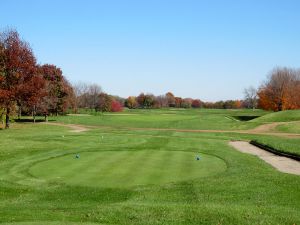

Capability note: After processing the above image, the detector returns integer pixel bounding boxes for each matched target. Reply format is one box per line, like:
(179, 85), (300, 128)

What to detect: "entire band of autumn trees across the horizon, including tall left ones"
(0, 30), (300, 128)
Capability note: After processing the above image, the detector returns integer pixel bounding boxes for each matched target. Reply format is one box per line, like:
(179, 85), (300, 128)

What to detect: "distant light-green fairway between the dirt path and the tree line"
(55, 109), (267, 130)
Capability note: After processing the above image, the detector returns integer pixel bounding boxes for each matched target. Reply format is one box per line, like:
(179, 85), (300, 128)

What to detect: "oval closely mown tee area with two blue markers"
(29, 150), (226, 188)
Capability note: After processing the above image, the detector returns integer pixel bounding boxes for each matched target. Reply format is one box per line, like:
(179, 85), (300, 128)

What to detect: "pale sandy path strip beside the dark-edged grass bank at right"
(229, 141), (300, 175)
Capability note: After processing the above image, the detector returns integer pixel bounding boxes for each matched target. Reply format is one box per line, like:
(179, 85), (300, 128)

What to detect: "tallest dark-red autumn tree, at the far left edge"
(0, 30), (42, 128)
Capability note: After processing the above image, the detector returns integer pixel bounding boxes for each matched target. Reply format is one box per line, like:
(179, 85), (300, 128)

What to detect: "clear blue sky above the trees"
(0, 0), (300, 101)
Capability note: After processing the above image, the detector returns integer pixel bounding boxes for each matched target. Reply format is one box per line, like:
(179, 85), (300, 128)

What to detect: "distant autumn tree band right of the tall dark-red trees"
(65, 67), (300, 112)
